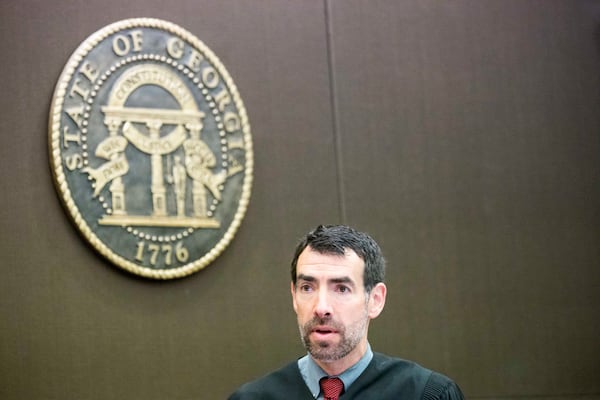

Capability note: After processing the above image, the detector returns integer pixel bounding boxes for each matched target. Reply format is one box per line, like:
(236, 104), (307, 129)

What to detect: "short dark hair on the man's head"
(291, 225), (385, 293)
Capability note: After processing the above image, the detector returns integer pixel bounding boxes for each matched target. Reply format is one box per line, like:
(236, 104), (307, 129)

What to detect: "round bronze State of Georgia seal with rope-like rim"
(49, 18), (253, 279)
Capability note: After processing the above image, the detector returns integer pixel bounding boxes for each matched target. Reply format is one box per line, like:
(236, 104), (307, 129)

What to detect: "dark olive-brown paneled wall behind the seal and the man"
(0, 0), (600, 400)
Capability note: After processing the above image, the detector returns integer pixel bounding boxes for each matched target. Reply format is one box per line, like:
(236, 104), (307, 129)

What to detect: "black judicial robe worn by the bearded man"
(229, 353), (464, 400)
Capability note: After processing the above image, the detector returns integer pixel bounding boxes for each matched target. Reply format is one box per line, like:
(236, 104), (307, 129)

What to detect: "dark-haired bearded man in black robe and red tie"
(230, 225), (463, 400)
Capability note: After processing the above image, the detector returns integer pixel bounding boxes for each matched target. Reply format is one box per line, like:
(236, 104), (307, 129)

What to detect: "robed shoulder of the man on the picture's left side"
(229, 361), (305, 400)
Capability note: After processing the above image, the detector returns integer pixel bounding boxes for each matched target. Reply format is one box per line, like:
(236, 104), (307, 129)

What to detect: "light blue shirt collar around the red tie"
(298, 343), (373, 399)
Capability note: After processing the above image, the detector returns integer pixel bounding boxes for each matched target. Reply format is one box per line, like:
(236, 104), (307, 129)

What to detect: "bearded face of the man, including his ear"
(292, 247), (385, 365)
